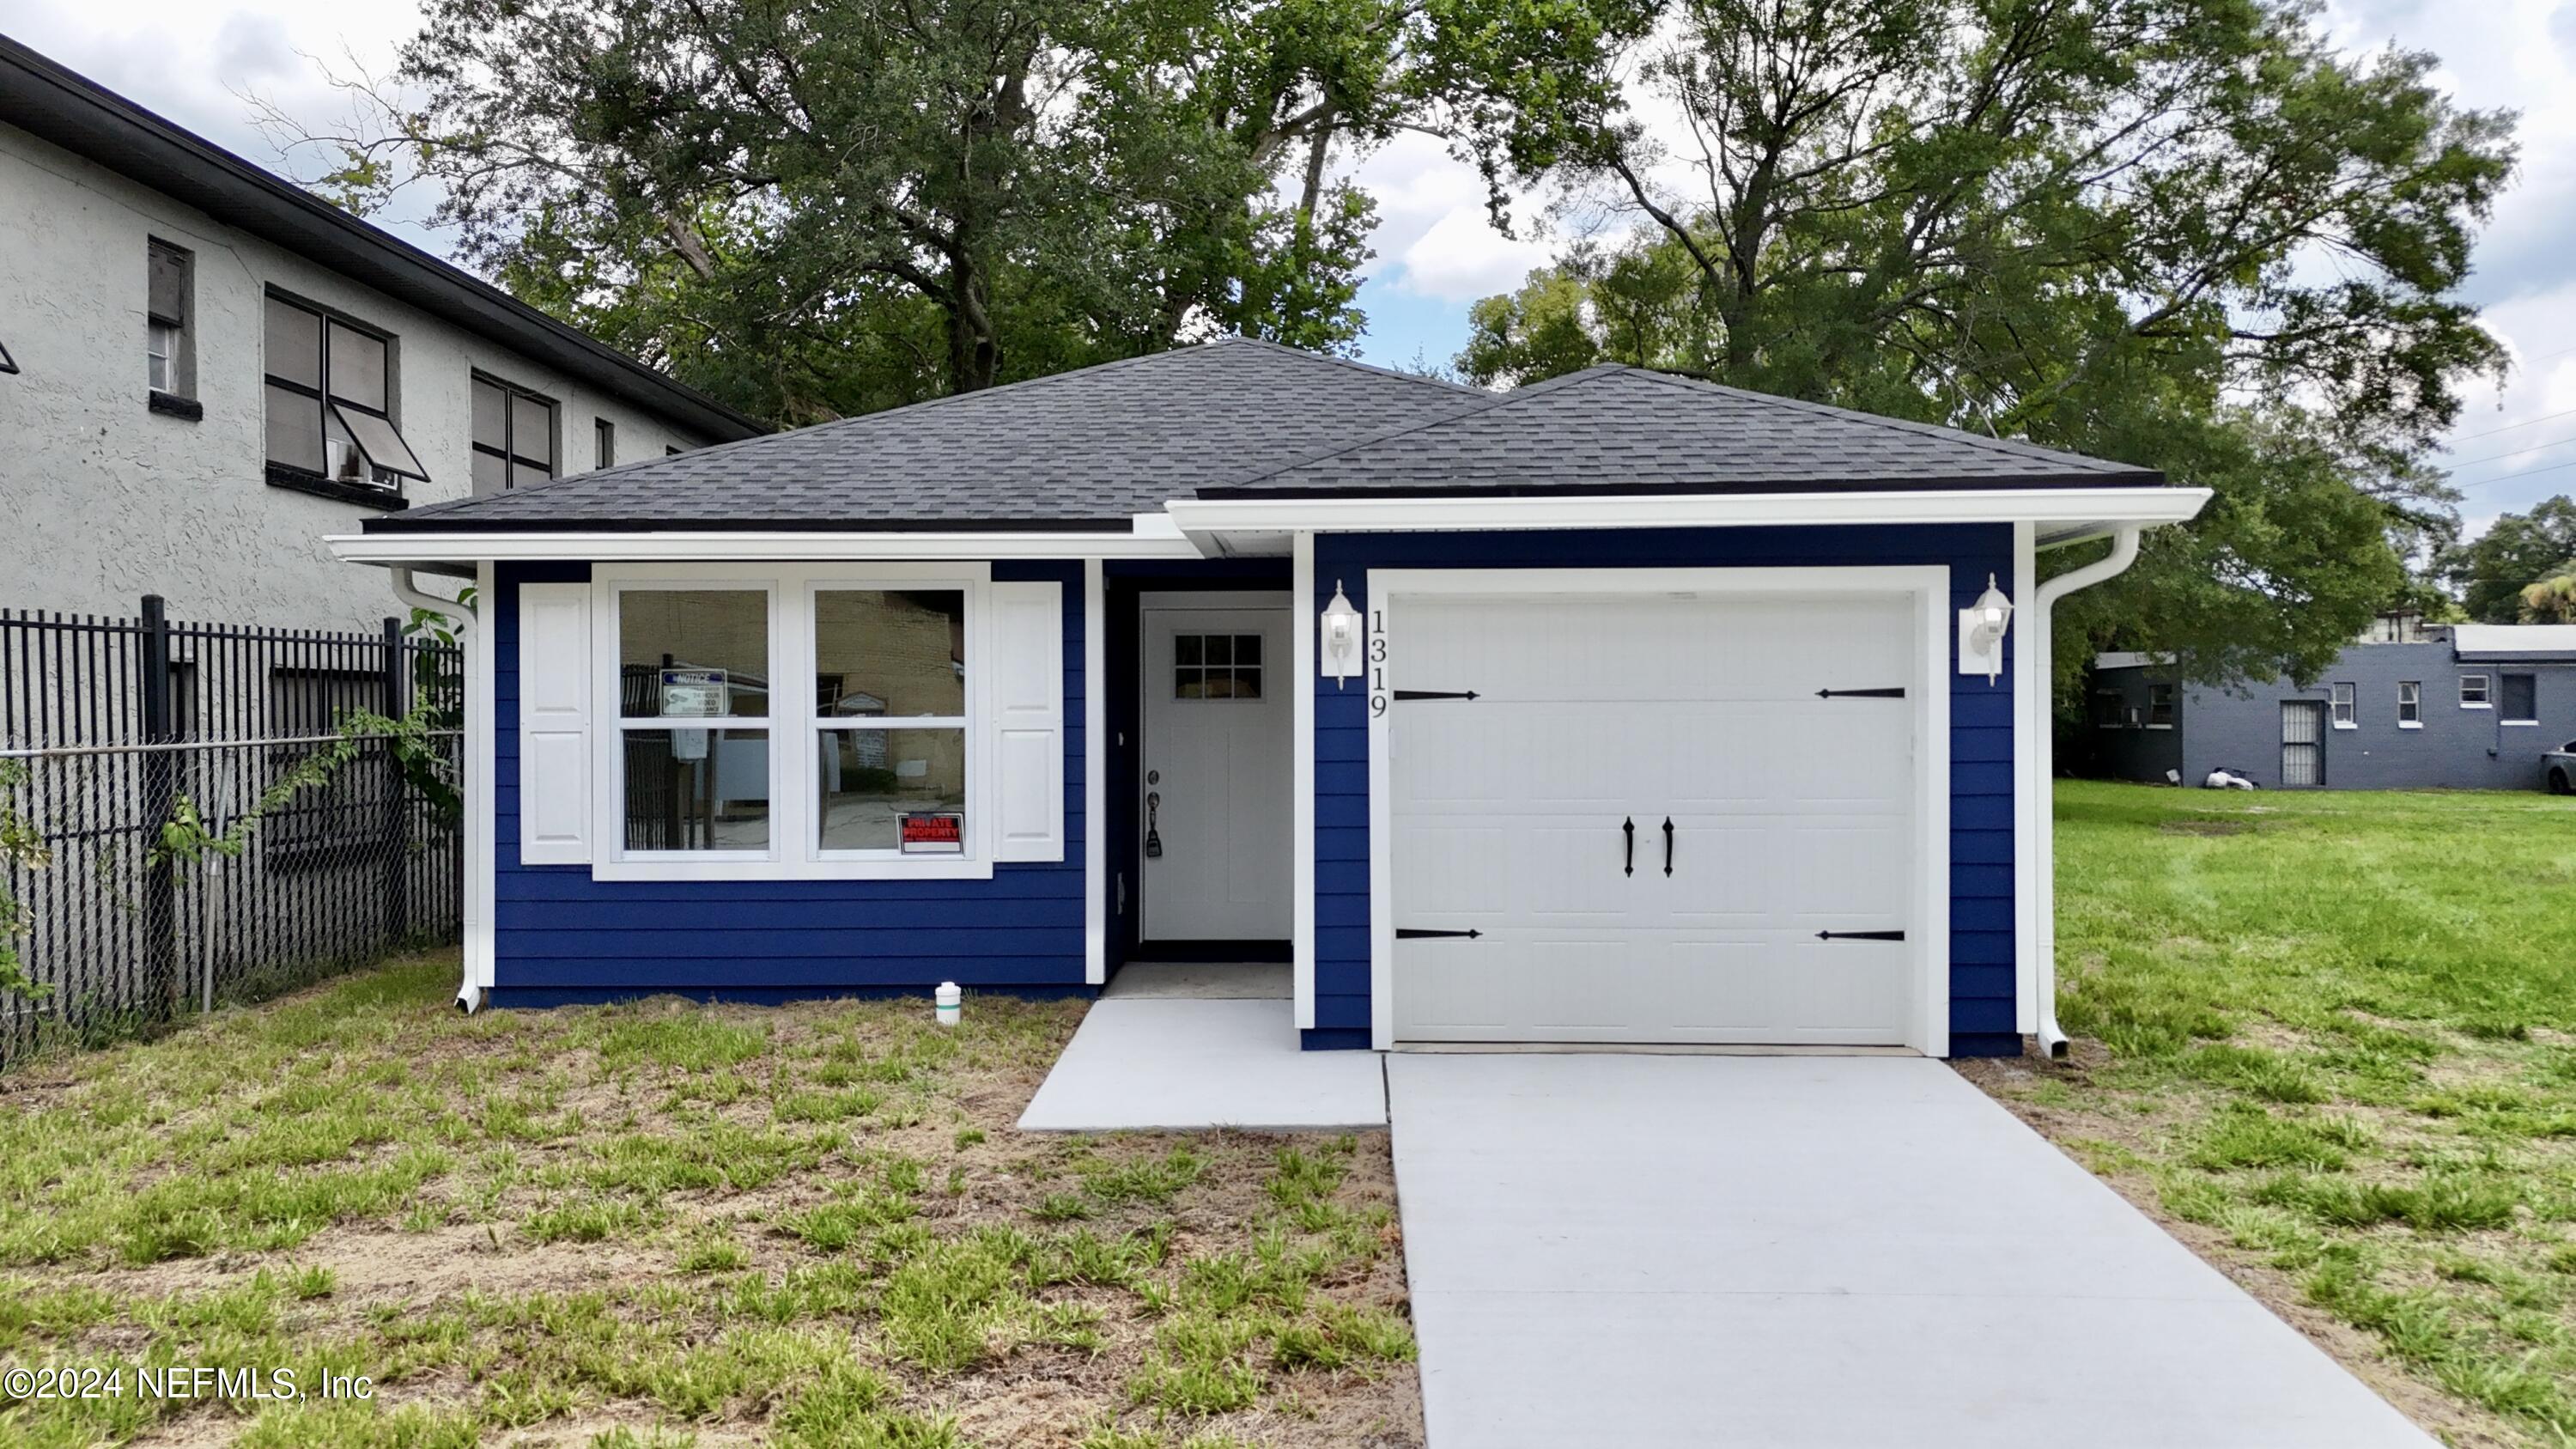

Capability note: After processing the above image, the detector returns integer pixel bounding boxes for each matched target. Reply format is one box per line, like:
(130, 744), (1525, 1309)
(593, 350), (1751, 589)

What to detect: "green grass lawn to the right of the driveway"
(1968, 784), (2576, 1444)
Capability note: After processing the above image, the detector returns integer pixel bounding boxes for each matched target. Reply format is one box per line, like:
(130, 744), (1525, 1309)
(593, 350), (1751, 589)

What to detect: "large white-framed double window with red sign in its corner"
(592, 562), (999, 880)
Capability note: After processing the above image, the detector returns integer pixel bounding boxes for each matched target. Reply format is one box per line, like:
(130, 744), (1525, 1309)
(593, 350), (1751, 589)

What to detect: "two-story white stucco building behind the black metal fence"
(0, 36), (762, 629)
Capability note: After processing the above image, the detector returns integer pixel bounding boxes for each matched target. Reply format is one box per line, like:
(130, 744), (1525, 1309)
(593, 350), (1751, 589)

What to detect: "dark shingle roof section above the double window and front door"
(368, 338), (1492, 533)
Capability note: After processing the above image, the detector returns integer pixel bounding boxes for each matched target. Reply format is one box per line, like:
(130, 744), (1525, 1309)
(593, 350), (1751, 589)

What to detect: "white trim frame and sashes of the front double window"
(590, 562), (994, 882)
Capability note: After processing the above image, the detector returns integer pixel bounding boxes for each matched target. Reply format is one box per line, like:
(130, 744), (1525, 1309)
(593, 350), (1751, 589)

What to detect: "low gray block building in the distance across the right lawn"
(2061, 618), (2576, 789)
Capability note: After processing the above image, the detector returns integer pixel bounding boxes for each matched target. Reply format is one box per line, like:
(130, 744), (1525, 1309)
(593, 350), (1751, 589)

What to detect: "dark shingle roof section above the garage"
(1200, 366), (2164, 497)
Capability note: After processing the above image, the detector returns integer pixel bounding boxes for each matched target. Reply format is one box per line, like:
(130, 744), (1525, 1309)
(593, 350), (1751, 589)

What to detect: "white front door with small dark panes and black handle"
(1139, 595), (1298, 941)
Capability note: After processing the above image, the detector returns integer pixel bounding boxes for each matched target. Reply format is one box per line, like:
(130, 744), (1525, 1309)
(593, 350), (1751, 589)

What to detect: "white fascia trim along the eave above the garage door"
(1164, 487), (2210, 551)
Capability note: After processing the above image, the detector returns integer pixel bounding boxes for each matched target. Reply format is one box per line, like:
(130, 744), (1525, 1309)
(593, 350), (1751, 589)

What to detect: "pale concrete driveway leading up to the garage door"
(1386, 1055), (2432, 1449)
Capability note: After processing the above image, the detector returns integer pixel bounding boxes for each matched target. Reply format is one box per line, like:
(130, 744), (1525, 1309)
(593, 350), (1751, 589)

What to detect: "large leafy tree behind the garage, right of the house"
(1461, 0), (2514, 680)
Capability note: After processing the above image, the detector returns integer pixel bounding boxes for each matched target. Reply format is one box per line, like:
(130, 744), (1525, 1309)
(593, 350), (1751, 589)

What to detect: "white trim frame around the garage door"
(1363, 564), (1955, 1057)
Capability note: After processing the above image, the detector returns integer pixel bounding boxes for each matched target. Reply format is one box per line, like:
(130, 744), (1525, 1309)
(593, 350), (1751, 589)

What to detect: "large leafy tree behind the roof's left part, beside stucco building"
(283, 0), (1636, 423)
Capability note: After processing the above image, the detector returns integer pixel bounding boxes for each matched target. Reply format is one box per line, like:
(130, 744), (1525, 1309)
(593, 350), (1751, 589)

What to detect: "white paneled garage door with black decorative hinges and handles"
(1388, 593), (1919, 1044)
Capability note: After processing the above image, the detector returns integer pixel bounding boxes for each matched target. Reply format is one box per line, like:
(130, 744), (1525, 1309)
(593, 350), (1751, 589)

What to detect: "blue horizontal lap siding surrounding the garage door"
(1306, 523), (2022, 1057)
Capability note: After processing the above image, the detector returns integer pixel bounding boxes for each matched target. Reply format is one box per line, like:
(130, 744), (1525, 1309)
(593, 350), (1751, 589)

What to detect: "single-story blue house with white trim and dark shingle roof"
(332, 338), (2208, 1055)
